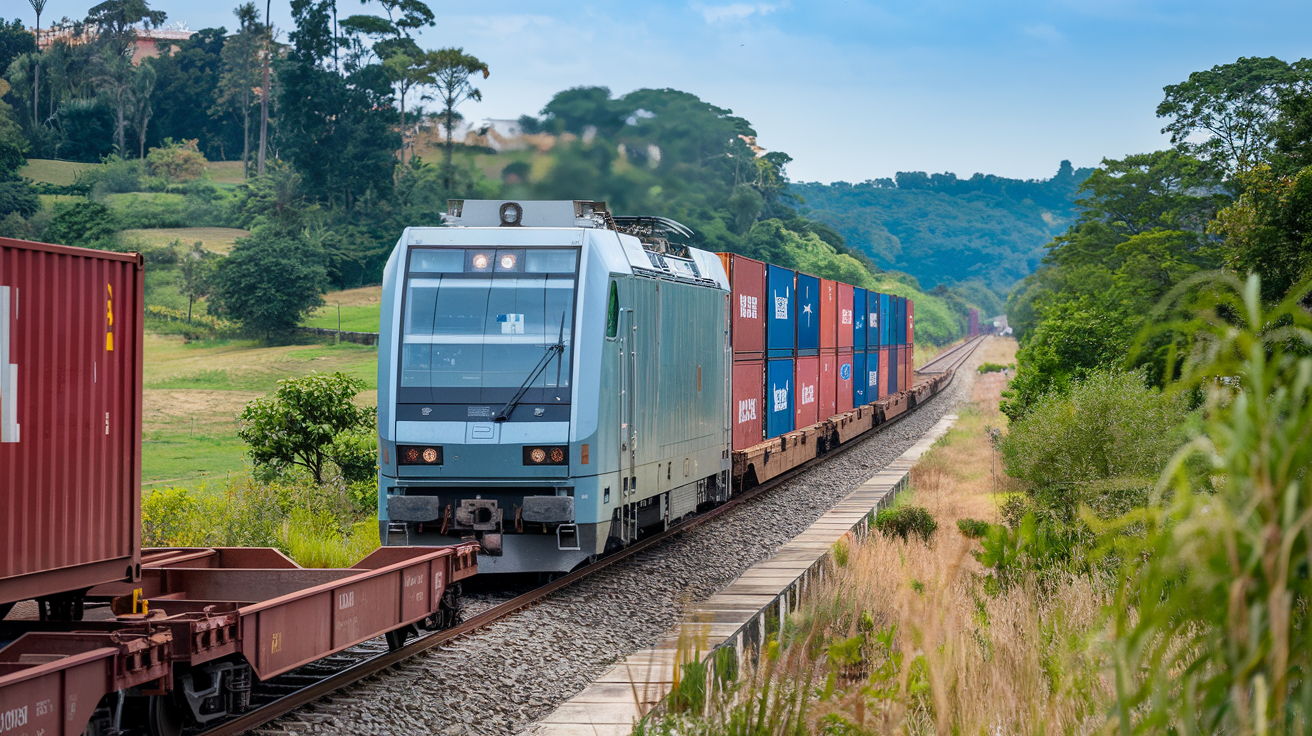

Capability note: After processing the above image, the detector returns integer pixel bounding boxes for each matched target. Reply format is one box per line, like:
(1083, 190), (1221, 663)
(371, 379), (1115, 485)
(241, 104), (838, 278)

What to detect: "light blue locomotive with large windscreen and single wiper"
(378, 201), (731, 573)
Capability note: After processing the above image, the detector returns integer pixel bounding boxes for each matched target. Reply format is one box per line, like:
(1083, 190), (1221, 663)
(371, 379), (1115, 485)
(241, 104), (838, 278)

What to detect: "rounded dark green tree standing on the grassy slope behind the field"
(213, 227), (328, 338)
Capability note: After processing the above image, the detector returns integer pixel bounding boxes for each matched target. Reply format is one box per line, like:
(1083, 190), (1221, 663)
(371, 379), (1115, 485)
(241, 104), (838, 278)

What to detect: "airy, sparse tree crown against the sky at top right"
(1157, 56), (1303, 176)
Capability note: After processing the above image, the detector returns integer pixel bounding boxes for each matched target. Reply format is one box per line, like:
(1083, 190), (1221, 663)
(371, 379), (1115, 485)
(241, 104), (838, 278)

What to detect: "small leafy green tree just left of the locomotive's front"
(237, 373), (377, 483)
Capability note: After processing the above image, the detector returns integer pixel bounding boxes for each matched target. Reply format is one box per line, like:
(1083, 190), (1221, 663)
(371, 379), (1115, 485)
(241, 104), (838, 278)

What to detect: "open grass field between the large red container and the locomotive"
(142, 335), (378, 489)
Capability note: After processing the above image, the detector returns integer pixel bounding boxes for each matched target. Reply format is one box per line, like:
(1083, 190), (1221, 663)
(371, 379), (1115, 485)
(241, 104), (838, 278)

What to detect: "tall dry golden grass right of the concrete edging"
(639, 338), (1114, 735)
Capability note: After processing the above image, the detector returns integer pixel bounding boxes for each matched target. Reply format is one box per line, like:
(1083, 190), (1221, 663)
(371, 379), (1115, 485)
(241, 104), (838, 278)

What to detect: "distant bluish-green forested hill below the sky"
(790, 161), (1093, 291)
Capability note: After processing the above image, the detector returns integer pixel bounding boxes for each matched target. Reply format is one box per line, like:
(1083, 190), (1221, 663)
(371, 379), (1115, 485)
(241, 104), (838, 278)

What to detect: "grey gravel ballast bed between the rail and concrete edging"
(260, 353), (979, 736)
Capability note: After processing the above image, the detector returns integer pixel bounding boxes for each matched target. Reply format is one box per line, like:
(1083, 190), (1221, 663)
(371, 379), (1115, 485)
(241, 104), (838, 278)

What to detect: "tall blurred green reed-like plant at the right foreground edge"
(1109, 276), (1312, 735)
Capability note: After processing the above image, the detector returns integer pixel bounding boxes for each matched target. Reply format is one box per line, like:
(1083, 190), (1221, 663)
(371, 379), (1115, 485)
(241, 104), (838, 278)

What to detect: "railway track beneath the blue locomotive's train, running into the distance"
(195, 336), (985, 736)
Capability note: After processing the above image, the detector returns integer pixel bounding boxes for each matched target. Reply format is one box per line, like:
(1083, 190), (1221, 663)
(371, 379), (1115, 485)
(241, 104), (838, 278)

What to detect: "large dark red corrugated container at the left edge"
(0, 237), (144, 606)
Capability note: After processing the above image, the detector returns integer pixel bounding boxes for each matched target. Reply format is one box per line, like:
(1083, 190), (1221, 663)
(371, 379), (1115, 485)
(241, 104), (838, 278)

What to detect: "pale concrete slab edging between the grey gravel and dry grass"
(525, 415), (956, 736)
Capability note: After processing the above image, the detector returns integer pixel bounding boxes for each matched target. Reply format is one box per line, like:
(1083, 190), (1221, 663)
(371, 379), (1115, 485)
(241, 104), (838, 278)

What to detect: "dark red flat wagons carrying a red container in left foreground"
(0, 239), (478, 736)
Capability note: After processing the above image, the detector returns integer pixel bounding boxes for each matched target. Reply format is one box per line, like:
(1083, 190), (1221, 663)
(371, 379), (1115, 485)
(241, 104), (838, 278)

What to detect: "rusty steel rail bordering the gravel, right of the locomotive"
(197, 335), (987, 736)
